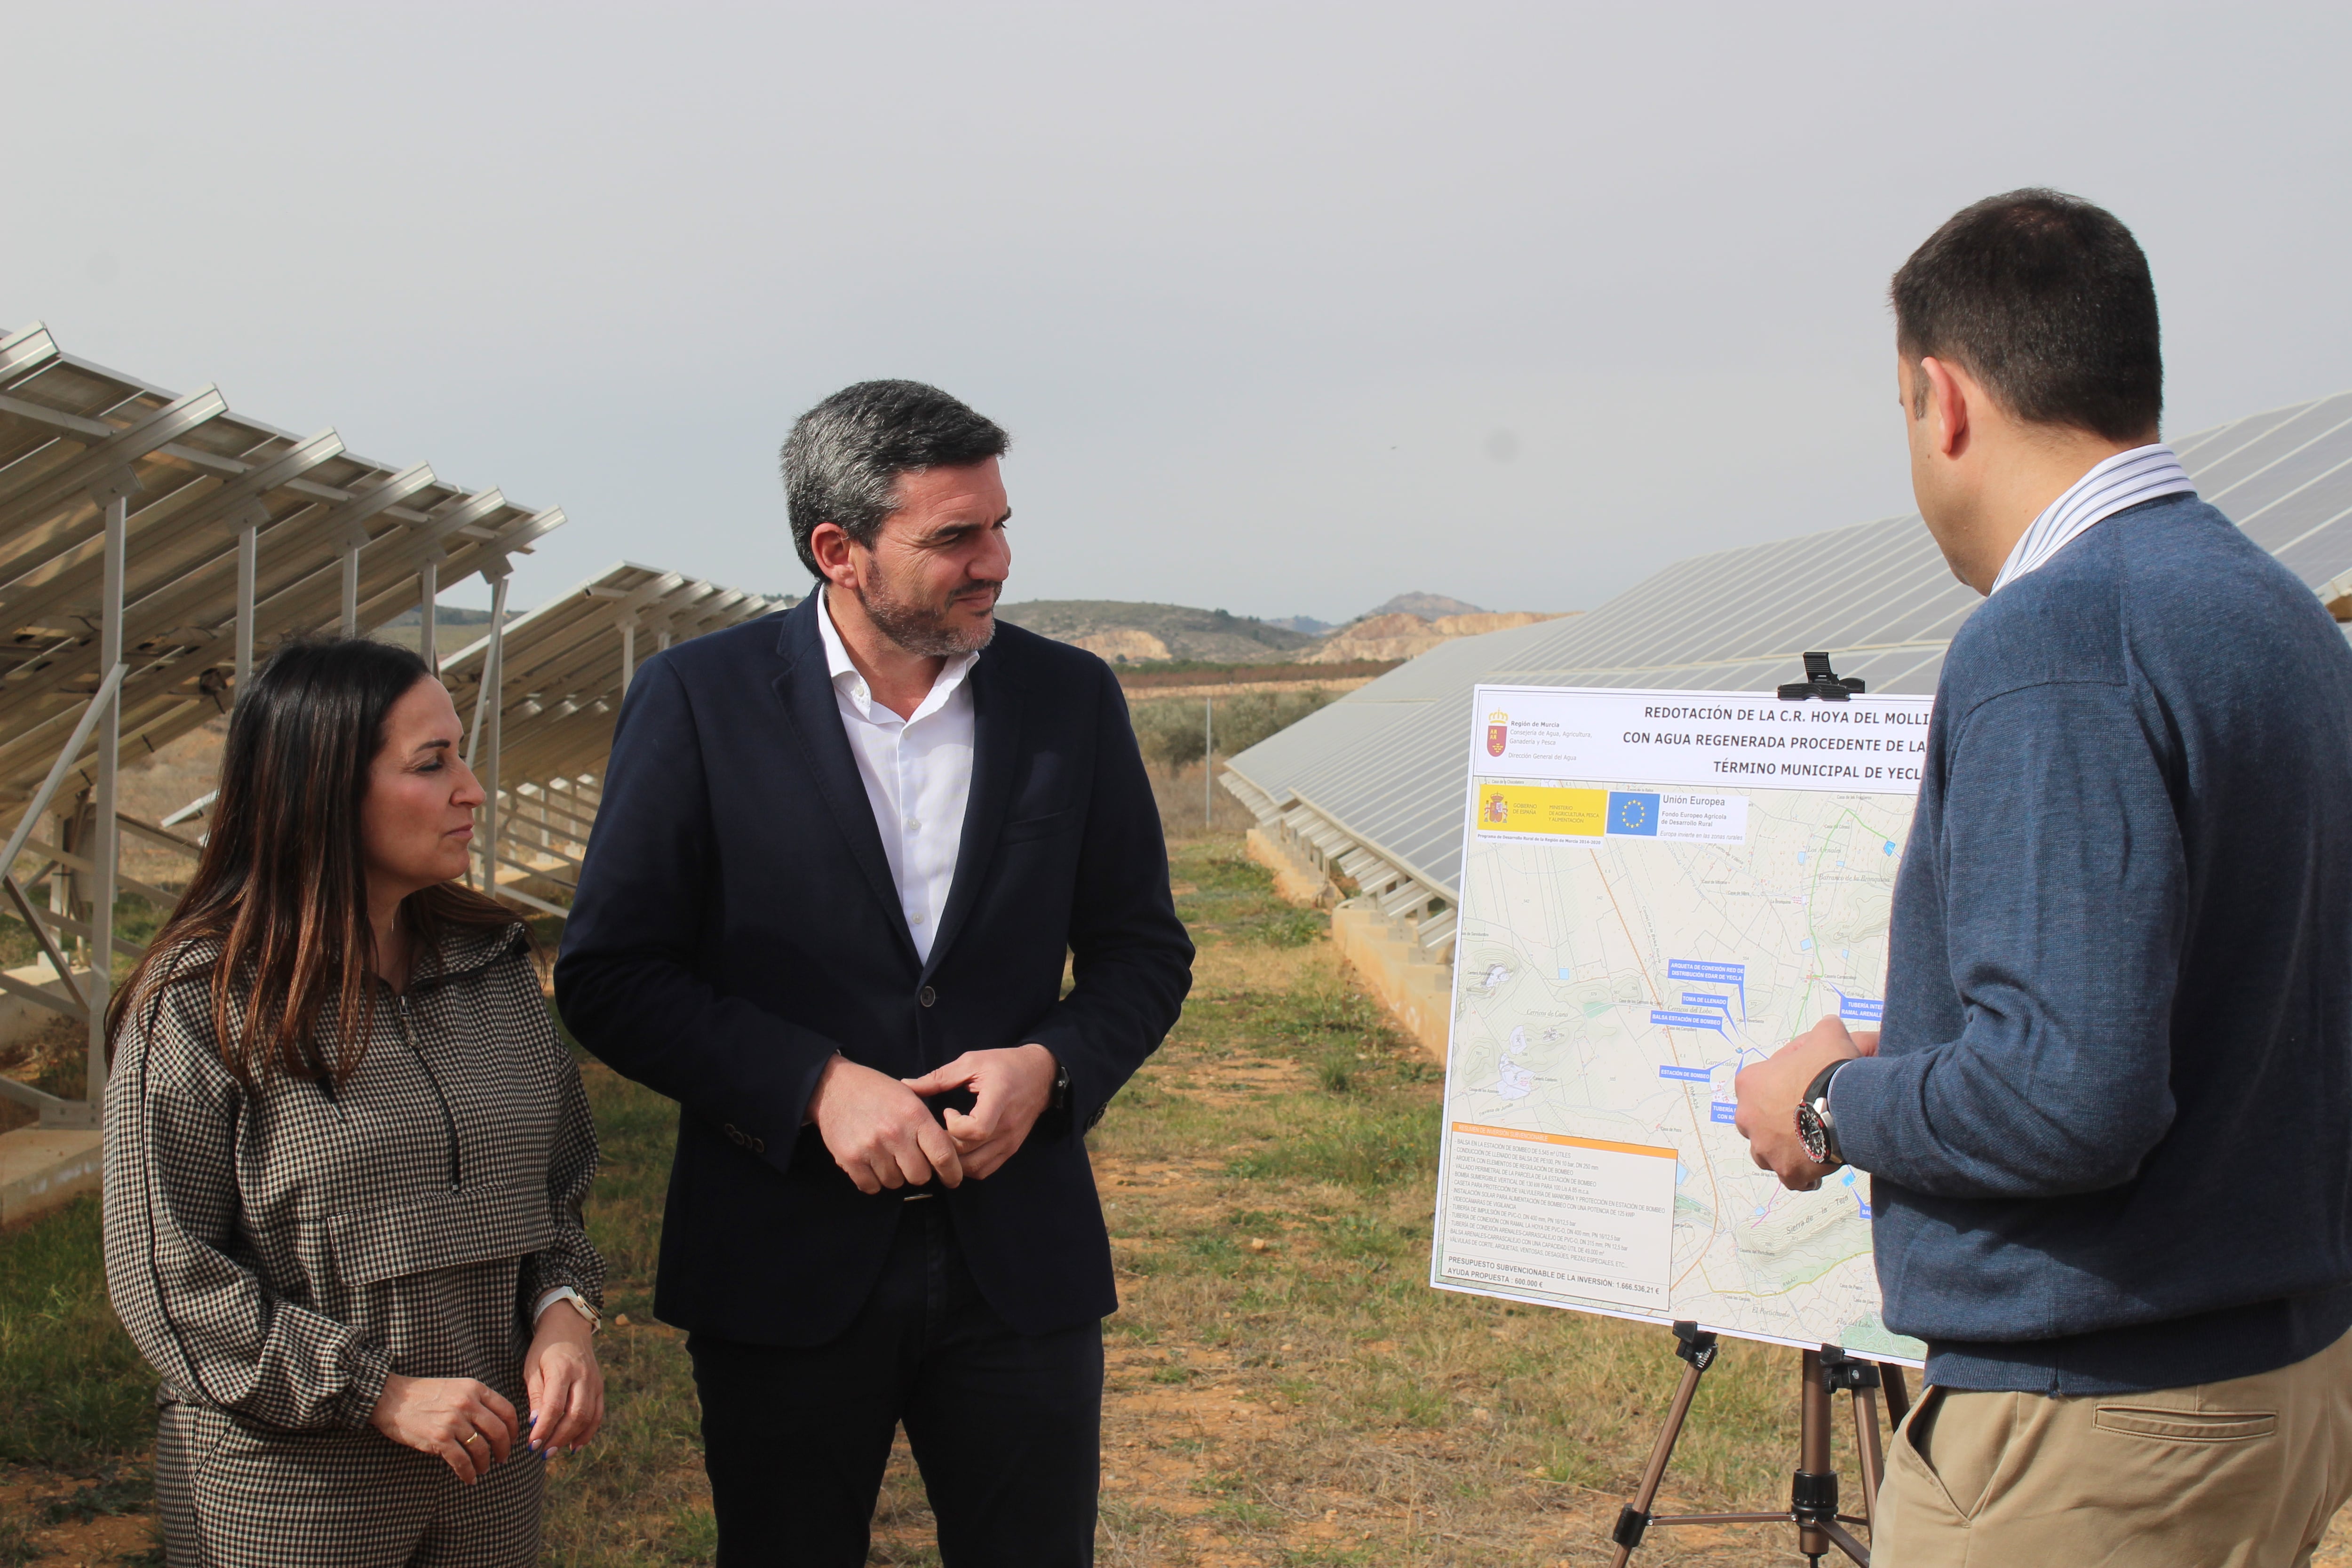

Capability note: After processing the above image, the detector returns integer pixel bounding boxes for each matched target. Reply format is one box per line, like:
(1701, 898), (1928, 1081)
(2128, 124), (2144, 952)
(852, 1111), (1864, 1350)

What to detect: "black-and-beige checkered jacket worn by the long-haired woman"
(106, 926), (604, 1432)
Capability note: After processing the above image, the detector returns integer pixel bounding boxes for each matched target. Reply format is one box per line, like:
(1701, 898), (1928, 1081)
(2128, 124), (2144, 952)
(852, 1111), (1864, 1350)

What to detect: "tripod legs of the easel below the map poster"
(1611, 1323), (1910, 1568)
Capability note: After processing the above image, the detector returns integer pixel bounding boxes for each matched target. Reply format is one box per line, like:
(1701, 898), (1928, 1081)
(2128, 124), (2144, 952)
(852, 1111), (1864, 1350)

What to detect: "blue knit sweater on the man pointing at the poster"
(1830, 496), (2352, 1394)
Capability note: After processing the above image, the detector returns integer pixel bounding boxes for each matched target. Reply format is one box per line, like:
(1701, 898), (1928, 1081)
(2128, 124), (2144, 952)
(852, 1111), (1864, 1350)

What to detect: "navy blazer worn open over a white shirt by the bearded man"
(555, 595), (1192, 1345)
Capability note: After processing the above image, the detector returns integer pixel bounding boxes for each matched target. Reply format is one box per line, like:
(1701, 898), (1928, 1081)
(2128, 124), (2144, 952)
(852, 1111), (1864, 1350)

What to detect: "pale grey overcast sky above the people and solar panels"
(0, 0), (2352, 618)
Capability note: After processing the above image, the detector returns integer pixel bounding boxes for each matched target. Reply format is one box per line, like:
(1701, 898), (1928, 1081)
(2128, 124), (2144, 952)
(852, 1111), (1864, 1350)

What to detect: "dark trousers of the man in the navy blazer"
(687, 1199), (1103, 1568)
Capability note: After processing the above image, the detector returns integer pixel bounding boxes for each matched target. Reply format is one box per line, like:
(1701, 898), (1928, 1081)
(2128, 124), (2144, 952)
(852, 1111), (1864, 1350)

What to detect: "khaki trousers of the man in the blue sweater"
(1870, 1335), (2352, 1568)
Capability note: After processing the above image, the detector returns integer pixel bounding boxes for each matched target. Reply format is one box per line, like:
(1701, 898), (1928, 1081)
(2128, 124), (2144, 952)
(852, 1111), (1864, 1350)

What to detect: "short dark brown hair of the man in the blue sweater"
(1889, 191), (2164, 442)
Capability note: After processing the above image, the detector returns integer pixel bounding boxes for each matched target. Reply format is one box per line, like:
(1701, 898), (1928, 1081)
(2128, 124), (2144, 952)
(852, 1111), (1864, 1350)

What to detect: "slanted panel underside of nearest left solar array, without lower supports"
(0, 327), (564, 799)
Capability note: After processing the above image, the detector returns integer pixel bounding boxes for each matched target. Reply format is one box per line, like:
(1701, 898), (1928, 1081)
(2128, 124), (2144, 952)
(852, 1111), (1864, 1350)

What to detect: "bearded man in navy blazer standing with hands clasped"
(555, 381), (1192, 1568)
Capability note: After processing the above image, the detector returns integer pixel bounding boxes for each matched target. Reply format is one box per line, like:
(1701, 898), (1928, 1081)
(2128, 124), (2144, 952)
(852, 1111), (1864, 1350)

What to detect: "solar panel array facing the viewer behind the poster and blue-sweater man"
(1223, 392), (2352, 950)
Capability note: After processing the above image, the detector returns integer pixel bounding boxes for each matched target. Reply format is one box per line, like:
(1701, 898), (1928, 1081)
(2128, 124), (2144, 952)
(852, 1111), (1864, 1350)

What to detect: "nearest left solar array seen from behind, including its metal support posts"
(0, 327), (562, 1126)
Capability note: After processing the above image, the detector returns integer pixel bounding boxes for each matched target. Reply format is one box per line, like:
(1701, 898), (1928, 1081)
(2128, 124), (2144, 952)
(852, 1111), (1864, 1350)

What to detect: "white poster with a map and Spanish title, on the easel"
(1430, 686), (1931, 1361)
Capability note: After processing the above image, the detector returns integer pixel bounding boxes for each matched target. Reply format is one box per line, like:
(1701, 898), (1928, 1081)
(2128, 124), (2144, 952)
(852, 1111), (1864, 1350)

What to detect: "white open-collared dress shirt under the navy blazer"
(816, 588), (981, 962)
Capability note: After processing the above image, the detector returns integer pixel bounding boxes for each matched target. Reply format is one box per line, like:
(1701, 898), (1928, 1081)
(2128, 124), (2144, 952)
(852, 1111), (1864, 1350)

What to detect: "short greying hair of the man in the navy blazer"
(783, 381), (1014, 576)
